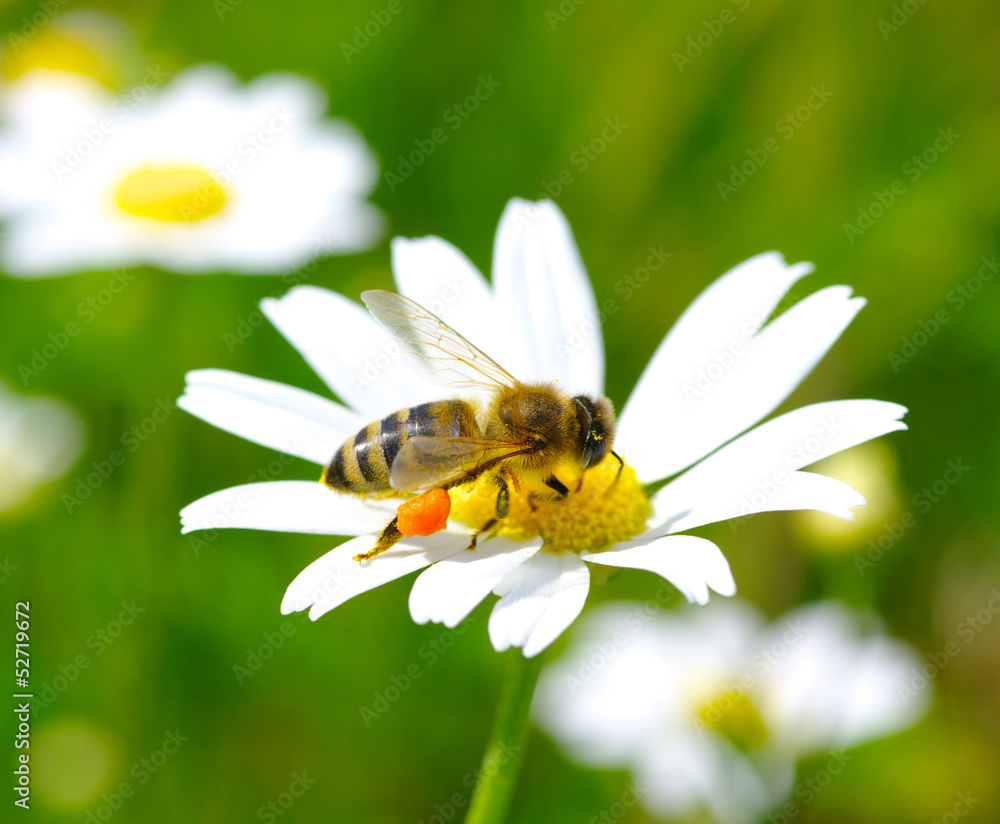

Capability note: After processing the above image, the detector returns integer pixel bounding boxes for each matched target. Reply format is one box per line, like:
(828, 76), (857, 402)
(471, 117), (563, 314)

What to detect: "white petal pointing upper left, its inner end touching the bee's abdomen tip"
(177, 369), (368, 466)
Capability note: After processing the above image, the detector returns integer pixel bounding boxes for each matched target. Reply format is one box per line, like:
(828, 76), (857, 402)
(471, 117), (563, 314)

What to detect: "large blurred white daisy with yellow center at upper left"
(0, 65), (381, 277)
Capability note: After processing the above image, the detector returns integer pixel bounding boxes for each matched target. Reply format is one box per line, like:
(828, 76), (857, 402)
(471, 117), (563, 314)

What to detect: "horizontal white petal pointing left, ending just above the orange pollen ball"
(181, 481), (395, 535)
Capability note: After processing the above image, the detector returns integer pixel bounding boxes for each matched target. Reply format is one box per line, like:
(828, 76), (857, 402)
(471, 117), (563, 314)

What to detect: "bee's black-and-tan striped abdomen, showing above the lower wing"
(321, 401), (479, 497)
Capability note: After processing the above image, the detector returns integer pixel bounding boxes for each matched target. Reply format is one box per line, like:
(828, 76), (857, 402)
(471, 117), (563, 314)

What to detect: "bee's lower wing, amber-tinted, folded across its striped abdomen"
(389, 435), (530, 492)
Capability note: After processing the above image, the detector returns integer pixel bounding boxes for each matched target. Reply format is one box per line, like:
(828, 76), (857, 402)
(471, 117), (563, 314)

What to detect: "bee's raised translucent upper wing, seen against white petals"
(361, 289), (517, 390)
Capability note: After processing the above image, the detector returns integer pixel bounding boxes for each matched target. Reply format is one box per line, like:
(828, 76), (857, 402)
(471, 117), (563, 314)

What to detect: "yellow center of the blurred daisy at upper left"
(116, 166), (226, 223)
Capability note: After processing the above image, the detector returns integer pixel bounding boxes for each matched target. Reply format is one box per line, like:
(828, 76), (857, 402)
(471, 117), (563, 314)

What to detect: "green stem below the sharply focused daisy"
(465, 649), (544, 824)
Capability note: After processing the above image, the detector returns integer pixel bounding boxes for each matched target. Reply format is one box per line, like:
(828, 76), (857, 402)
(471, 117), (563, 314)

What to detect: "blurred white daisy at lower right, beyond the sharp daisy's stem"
(532, 600), (929, 824)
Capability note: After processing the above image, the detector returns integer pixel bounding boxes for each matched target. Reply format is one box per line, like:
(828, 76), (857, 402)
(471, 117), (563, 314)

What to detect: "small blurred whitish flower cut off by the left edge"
(0, 383), (84, 512)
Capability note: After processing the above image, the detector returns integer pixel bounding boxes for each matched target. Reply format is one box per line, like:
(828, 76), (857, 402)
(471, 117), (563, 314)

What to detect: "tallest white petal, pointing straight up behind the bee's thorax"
(487, 198), (604, 393)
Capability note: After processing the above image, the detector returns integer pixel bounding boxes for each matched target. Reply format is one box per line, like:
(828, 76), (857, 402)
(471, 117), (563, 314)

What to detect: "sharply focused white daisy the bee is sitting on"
(178, 200), (905, 657)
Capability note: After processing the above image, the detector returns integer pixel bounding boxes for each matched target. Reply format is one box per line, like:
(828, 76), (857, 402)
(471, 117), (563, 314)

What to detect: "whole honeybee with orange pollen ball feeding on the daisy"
(321, 290), (622, 562)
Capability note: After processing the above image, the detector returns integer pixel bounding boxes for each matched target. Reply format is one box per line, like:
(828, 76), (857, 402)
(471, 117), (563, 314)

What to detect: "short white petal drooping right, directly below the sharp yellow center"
(580, 535), (736, 606)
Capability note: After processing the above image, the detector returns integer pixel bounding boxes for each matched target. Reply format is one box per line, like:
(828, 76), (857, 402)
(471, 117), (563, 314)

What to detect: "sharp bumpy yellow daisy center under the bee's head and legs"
(449, 455), (650, 552)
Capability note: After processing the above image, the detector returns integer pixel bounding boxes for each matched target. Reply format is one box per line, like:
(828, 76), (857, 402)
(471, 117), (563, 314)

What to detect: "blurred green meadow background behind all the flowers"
(0, 0), (1000, 824)
